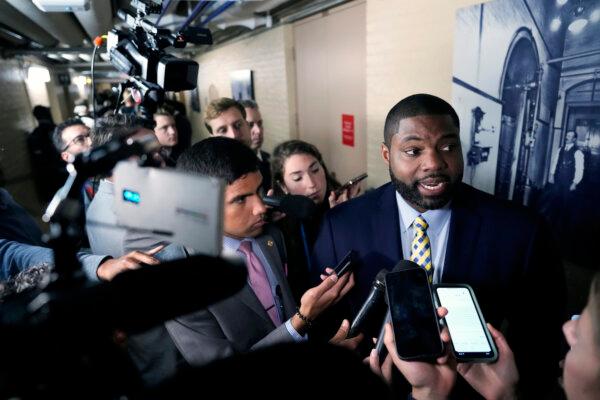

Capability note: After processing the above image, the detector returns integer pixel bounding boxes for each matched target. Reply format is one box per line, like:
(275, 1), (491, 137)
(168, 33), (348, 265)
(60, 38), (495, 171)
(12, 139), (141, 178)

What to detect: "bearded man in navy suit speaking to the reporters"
(313, 94), (566, 393)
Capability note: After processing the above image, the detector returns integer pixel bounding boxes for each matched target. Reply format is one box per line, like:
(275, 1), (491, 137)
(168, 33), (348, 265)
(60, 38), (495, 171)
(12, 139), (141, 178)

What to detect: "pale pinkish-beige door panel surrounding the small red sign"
(294, 1), (367, 182)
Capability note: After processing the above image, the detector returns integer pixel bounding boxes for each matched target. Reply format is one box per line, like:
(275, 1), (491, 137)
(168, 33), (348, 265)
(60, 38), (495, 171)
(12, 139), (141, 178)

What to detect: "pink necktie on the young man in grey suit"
(238, 240), (281, 326)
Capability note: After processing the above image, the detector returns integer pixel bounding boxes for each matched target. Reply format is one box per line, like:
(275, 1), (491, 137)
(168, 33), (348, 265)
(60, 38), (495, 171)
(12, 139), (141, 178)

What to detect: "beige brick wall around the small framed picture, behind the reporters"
(190, 25), (297, 151)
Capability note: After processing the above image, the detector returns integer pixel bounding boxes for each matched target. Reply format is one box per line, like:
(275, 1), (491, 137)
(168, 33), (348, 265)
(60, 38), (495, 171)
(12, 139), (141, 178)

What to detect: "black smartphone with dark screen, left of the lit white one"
(385, 268), (444, 361)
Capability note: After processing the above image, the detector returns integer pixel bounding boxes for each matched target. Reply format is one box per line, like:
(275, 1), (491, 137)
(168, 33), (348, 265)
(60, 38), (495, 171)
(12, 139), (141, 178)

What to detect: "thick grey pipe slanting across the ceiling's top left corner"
(6, 0), (86, 46)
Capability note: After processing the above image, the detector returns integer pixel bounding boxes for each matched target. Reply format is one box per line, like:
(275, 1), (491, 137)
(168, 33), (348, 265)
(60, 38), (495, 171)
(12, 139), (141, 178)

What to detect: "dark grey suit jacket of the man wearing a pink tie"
(163, 229), (296, 366)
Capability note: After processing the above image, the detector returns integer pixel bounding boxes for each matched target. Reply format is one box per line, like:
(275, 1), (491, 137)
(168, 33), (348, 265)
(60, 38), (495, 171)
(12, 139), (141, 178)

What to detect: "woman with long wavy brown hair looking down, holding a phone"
(271, 140), (360, 300)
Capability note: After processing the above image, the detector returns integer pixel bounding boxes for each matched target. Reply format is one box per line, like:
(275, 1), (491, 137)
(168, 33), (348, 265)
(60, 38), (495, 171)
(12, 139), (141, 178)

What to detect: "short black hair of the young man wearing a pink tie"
(177, 136), (259, 185)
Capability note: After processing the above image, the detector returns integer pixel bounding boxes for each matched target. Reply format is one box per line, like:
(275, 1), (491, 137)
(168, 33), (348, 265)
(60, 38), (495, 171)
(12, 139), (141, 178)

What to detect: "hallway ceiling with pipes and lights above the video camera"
(0, 0), (349, 72)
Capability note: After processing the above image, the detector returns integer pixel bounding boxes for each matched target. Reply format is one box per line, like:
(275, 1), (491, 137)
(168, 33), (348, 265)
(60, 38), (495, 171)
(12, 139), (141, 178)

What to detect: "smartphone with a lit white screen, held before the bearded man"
(434, 283), (498, 362)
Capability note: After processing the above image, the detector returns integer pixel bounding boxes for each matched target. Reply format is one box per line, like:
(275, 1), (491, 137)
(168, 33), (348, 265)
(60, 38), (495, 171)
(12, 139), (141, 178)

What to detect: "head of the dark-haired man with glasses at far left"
(52, 118), (92, 162)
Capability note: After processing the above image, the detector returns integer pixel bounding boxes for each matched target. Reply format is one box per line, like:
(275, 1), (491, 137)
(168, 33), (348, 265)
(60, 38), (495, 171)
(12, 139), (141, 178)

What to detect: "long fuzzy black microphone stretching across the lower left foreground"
(0, 255), (247, 334)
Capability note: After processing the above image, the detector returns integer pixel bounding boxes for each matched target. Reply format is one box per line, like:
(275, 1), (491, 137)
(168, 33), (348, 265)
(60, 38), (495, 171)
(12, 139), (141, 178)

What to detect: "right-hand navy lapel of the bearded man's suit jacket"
(441, 184), (481, 283)
